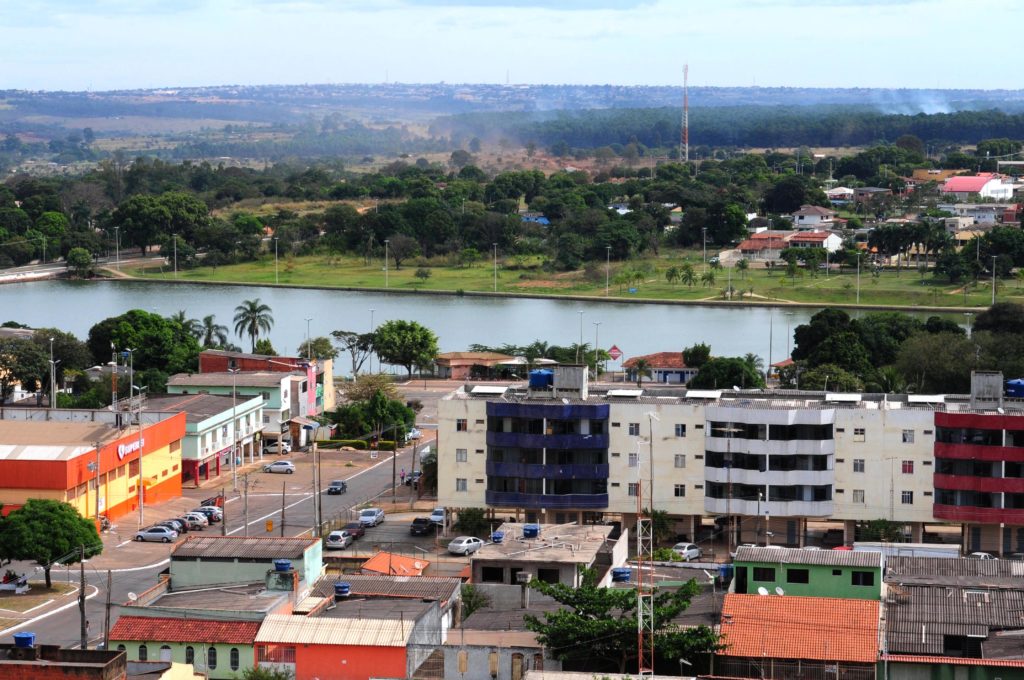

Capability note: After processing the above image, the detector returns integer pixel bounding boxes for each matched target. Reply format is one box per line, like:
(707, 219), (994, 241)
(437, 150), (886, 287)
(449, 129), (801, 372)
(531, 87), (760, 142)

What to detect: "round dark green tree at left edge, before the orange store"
(0, 499), (103, 588)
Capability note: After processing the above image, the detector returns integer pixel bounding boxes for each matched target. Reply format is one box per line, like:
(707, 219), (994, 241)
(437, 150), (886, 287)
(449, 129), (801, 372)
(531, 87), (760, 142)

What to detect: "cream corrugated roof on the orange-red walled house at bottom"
(256, 614), (414, 647)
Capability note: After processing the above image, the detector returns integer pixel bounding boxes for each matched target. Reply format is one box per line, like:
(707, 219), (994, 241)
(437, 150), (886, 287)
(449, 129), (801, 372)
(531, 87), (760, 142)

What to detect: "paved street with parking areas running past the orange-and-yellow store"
(0, 436), (434, 646)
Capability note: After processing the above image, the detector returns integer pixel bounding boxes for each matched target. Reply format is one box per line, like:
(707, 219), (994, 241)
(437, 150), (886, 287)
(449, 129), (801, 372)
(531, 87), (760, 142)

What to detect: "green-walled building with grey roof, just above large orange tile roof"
(733, 546), (883, 600)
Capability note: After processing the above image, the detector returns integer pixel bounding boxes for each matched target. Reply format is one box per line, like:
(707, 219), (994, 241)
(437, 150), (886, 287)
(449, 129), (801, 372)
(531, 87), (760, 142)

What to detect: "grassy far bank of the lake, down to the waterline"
(112, 256), (1007, 313)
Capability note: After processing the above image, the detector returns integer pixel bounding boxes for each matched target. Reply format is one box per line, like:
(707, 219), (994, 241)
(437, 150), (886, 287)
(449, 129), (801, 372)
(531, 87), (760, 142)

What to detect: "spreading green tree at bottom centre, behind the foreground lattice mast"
(523, 568), (718, 673)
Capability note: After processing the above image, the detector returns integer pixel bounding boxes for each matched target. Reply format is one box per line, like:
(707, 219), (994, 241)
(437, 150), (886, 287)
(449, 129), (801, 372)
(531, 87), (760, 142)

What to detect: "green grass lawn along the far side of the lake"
(126, 251), (1024, 307)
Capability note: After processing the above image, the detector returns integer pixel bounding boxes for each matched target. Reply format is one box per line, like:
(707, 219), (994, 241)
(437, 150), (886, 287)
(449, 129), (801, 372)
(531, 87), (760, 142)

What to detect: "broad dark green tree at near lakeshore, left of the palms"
(87, 309), (200, 374)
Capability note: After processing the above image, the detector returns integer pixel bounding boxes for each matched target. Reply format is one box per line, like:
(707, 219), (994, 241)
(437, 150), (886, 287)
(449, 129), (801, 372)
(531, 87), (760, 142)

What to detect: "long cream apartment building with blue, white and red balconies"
(438, 367), (1024, 551)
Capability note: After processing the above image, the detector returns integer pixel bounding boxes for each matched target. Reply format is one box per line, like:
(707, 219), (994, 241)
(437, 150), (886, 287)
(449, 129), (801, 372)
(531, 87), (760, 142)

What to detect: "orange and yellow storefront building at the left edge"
(0, 412), (185, 520)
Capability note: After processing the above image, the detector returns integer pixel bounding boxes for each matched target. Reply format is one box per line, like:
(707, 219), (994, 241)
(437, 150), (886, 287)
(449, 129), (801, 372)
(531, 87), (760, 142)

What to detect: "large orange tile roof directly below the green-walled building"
(722, 594), (879, 664)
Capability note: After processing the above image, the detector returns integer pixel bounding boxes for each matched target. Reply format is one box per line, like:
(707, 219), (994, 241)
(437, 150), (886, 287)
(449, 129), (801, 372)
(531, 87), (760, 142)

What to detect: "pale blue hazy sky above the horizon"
(0, 0), (1024, 90)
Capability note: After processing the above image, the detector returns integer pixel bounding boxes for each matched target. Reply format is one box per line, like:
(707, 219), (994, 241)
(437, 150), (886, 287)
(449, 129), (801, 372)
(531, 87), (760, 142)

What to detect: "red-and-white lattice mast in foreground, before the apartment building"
(637, 413), (657, 678)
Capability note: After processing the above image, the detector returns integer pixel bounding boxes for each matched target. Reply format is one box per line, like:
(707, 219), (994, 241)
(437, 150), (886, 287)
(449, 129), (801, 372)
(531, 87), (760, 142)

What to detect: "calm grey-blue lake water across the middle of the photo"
(0, 281), (962, 372)
